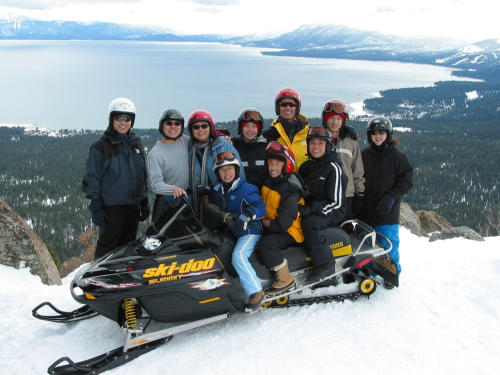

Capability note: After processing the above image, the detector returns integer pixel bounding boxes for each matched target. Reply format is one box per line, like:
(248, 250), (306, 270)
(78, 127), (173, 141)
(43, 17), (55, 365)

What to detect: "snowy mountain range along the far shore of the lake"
(0, 19), (500, 82)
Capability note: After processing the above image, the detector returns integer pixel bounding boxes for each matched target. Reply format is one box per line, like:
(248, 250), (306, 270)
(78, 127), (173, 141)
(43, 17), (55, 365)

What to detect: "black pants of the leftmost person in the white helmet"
(94, 205), (140, 259)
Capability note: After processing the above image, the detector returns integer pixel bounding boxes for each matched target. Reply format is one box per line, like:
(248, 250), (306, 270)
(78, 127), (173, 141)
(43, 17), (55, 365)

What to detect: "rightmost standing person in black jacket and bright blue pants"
(359, 116), (413, 289)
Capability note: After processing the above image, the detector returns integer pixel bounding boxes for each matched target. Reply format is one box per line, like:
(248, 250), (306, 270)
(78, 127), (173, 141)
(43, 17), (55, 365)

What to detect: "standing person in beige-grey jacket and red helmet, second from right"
(321, 99), (365, 219)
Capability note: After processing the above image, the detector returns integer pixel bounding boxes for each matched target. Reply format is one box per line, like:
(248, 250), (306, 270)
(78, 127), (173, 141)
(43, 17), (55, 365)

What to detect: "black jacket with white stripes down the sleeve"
(299, 151), (347, 223)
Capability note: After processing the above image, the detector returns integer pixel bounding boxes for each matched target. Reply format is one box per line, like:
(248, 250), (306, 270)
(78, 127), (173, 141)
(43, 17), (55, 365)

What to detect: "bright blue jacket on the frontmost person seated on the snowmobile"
(214, 177), (266, 238)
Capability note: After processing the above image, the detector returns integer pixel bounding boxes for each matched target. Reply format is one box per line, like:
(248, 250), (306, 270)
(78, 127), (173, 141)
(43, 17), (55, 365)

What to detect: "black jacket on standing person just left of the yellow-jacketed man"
(232, 136), (267, 189)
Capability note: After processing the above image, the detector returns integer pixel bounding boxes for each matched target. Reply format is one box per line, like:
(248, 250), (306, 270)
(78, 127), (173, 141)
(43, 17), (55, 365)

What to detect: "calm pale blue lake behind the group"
(0, 41), (468, 129)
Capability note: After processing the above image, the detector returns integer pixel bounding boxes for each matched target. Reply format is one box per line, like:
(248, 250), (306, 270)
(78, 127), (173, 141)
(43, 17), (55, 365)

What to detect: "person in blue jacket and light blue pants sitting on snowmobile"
(213, 151), (266, 310)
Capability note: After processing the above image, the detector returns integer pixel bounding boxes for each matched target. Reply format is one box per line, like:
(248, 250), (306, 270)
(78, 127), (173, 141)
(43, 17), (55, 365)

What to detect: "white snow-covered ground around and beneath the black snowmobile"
(0, 227), (500, 375)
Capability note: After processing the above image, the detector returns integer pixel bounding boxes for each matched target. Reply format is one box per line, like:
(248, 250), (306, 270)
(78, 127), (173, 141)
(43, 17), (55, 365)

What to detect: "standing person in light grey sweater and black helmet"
(146, 108), (189, 222)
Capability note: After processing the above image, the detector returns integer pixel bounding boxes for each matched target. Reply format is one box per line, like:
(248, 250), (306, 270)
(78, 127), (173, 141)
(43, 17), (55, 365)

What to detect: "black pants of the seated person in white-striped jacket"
(301, 215), (337, 270)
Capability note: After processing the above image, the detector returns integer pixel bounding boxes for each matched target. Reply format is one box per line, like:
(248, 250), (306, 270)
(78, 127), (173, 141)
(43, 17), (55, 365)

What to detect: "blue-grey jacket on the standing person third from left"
(189, 137), (245, 191)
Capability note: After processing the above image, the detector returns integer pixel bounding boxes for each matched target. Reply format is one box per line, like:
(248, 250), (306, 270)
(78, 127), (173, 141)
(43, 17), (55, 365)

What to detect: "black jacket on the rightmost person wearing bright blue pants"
(359, 144), (413, 225)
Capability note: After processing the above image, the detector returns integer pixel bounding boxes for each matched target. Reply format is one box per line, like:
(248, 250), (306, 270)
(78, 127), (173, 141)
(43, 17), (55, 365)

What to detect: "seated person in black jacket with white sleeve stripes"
(299, 127), (347, 283)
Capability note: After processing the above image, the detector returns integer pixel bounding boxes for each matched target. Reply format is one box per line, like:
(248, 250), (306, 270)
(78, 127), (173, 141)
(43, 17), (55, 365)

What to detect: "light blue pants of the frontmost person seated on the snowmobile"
(231, 234), (262, 296)
